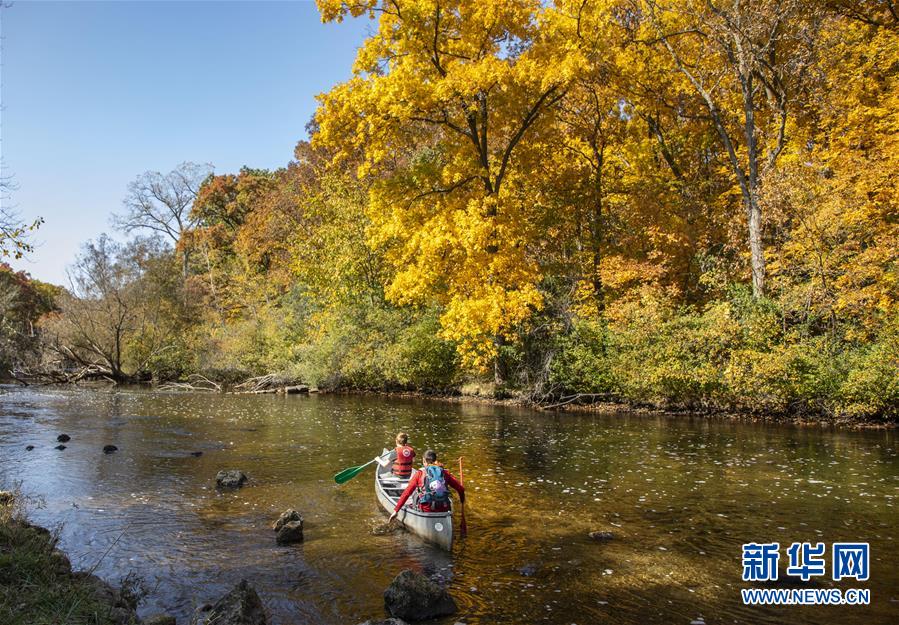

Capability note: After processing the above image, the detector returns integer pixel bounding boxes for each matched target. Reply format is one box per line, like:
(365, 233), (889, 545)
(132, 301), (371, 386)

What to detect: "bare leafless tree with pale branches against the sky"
(113, 162), (212, 278)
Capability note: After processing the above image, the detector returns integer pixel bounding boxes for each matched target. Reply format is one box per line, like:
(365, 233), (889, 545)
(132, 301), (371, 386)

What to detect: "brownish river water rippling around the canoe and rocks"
(0, 387), (899, 625)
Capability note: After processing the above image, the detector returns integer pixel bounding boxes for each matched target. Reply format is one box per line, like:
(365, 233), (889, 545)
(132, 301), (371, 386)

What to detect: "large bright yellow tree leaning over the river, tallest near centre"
(313, 0), (578, 382)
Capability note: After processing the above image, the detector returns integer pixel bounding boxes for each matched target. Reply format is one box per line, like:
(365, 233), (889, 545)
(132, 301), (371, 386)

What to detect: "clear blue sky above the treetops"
(0, 0), (372, 285)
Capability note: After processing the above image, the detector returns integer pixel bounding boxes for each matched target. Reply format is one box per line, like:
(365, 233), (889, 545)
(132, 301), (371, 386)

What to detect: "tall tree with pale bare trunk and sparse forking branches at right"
(637, 0), (816, 297)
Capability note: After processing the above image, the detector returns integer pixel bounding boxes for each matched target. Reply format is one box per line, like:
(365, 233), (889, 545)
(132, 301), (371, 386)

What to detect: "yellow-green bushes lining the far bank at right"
(551, 289), (899, 418)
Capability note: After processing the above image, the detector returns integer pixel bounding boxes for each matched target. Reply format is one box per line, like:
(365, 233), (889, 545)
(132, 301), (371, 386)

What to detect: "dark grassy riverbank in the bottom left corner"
(0, 495), (139, 625)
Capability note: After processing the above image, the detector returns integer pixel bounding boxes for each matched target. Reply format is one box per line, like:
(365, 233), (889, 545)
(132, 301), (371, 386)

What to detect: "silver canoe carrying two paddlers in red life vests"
(375, 449), (453, 551)
